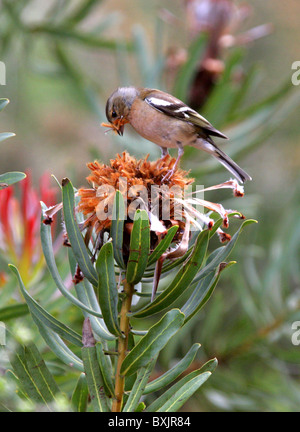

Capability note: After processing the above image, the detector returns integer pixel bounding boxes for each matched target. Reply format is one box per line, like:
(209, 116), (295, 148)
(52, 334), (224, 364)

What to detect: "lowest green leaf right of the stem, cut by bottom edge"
(145, 369), (211, 412)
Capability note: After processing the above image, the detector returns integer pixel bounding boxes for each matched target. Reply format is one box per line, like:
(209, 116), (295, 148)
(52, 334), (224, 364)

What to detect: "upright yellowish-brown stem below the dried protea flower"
(112, 279), (134, 412)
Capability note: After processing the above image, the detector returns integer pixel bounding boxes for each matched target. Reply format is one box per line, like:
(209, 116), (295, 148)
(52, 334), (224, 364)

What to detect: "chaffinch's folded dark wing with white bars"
(144, 90), (227, 139)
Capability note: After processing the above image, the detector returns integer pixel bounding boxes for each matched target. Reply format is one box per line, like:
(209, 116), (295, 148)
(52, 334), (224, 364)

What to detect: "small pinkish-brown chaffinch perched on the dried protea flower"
(103, 87), (251, 183)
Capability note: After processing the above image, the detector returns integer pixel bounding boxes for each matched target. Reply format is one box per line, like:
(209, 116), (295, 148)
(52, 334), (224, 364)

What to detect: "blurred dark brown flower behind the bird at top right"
(167, 0), (272, 110)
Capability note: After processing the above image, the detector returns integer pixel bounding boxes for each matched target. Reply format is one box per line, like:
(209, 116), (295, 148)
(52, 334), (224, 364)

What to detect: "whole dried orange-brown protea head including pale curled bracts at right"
(77, 152), (243, 263)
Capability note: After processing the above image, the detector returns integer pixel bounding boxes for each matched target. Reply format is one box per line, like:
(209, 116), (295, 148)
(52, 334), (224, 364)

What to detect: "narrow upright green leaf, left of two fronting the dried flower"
(110, 191), (125, 269)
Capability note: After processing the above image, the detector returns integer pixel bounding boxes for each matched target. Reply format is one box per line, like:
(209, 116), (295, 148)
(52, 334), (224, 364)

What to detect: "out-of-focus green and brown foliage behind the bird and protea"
(0, 0), (300, 411)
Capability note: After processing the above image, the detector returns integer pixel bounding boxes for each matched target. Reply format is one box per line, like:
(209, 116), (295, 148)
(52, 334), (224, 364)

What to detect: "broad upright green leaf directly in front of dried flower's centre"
(126, 210), (150, 284)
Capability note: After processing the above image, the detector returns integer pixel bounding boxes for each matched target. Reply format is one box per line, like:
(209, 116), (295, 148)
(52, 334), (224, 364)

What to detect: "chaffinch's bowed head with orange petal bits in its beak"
(106, 87), (138, 135)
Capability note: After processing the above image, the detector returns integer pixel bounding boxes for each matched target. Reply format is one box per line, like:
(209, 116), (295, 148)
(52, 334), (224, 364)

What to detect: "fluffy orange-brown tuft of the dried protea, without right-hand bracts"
(78, 152), (194, 262)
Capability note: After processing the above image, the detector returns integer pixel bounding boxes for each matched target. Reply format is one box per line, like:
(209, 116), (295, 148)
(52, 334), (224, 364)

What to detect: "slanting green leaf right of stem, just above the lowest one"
(143, 343), (201, 394)
